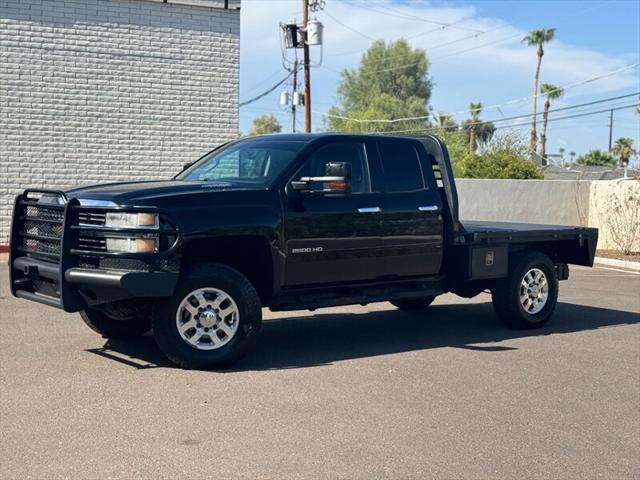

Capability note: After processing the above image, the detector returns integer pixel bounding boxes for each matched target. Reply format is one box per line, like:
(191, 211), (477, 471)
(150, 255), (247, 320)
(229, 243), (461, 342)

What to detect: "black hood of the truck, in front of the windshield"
(65, 180), (264, 205)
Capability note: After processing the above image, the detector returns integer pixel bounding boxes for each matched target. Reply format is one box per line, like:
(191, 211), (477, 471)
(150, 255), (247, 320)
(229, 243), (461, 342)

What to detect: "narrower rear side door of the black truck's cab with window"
(376, 138), (443, 277)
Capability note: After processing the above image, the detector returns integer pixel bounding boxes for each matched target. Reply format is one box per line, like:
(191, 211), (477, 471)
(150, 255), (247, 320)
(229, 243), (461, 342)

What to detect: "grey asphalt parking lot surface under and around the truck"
(0, 262), (640, 479)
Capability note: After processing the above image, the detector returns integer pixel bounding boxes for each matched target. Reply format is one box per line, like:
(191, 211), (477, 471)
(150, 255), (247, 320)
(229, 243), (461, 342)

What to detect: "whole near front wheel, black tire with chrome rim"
(153, 263), (262, 369)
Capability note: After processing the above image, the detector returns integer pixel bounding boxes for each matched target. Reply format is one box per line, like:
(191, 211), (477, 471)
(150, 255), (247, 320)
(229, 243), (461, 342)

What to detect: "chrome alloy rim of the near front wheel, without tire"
(176, 288), (240, 350)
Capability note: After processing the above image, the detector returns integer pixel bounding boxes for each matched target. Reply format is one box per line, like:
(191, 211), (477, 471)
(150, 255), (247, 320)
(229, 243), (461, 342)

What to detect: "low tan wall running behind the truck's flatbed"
(457, 178), (640, 251)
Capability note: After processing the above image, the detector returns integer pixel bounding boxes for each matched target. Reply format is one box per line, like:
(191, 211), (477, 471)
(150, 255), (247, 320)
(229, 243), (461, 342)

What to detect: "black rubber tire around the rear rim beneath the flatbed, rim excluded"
(491, 252), (558, 329)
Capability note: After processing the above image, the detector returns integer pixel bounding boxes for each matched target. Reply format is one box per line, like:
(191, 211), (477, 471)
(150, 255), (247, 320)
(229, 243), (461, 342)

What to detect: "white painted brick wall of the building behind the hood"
(0, 0), (240, 240)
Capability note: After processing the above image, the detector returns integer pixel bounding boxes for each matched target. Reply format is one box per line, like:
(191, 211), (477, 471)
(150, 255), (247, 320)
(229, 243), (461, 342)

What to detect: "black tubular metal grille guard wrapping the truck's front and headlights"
(9, 189), (182, 311)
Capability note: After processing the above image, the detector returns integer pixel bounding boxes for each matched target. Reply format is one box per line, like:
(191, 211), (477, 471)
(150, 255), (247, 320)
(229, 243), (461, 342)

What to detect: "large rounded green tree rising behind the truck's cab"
(326, 39), (432, 132)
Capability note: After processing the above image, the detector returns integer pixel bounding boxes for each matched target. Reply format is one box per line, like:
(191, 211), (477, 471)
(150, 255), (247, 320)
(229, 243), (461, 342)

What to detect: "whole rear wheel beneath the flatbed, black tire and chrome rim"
(491, 252), (558, 329)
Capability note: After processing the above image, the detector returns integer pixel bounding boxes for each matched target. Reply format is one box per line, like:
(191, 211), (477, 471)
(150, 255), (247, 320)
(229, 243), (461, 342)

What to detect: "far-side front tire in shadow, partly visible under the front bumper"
(80, 302), (151, 338)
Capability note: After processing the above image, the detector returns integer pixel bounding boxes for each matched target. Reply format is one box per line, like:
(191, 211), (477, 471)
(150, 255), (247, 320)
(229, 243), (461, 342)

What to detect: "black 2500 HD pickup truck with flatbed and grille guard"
(9, 134), (598, 368)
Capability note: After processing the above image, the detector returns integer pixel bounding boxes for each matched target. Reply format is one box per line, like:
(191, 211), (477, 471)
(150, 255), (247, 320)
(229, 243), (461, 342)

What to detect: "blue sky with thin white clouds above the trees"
(240, 0), (640, 158)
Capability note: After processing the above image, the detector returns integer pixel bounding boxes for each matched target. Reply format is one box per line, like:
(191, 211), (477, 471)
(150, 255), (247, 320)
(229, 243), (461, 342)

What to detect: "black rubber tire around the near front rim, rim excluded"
(152, 263), (262, 369)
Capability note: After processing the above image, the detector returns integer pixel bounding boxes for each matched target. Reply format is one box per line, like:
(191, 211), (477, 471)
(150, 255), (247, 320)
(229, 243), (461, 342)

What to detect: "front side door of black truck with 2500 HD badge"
(284, 139), (387, 286)
